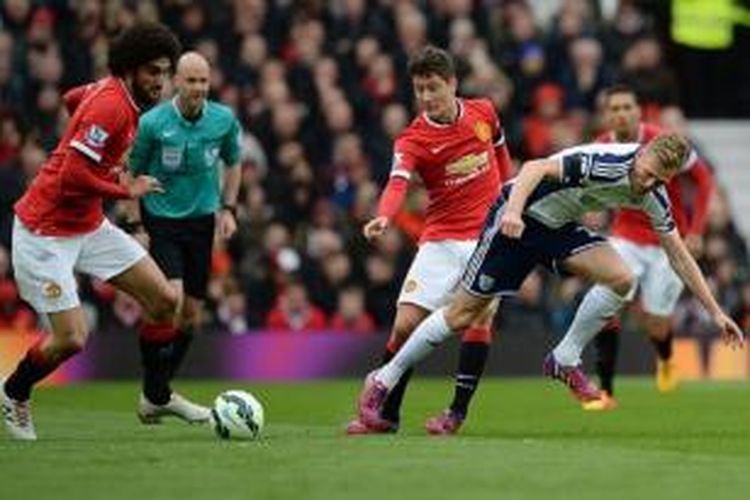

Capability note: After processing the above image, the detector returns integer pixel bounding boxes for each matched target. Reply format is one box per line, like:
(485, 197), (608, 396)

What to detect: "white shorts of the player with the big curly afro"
(12, 217), (146, 313)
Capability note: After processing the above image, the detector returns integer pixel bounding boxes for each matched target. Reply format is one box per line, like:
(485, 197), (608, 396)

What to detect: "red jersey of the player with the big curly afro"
(15, 77), (139, 236)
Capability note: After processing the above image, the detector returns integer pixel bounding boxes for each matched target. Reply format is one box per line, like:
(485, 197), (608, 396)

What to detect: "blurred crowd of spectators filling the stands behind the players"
(0, 0), (750, 334)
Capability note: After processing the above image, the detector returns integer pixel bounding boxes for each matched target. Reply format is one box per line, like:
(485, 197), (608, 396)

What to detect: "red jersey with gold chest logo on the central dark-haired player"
(384, 99), (511, 242)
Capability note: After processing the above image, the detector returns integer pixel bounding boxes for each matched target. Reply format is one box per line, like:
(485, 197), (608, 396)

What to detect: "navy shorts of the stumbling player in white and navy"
(461, 198), (607, 297)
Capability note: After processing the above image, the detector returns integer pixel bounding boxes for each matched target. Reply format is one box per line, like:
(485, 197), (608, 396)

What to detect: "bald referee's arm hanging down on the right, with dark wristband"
(219, 118), (242, 238)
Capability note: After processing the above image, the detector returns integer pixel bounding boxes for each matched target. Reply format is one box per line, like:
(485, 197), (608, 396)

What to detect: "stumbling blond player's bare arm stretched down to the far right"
(660, 229), (744, 346)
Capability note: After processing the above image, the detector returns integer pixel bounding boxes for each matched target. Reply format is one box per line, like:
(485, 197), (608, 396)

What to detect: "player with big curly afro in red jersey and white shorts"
(2, 23), (189, 440)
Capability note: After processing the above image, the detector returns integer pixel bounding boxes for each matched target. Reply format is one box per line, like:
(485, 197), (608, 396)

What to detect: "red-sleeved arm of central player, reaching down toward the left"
(362, 142), (416, 240)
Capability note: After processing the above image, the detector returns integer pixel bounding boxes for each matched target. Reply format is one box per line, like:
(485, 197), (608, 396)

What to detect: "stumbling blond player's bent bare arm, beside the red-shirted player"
(500, 158), (565, 238)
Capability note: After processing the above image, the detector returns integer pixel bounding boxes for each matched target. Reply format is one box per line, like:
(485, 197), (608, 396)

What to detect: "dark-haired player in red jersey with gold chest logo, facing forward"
(347, 47), (512, 434)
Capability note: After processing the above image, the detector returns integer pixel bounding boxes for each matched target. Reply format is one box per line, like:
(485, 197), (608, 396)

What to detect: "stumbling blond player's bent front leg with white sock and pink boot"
(543, 241), (636, 402)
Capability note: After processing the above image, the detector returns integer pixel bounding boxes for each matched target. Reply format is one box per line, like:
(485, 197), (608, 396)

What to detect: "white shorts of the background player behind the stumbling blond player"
(610, 238), (684, 317)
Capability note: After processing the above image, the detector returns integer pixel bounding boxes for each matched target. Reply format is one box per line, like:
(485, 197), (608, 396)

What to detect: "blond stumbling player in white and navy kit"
(359, 134), (743, 422)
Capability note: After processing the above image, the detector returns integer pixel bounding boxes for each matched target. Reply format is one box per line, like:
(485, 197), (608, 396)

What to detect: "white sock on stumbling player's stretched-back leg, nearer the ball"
(376, 308), (453, 390)
